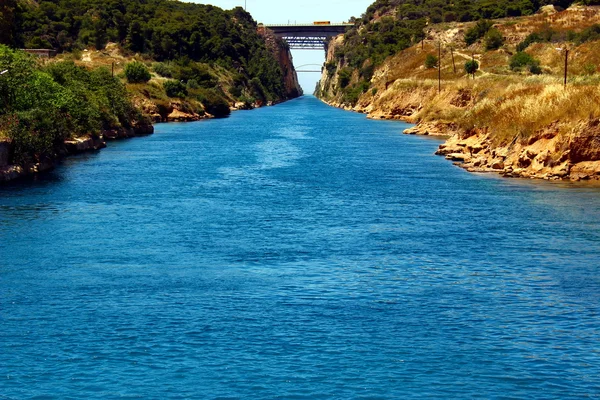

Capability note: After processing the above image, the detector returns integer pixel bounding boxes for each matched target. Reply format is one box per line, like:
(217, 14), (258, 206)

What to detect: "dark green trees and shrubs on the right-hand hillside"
(321, 0), (600, 104)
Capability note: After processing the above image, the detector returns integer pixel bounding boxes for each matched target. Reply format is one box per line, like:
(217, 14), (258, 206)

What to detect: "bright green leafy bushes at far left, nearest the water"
(0, 45), (149, 163)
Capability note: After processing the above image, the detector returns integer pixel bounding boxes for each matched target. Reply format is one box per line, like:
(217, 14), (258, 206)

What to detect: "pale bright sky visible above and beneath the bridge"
(188, 0), (375, 94)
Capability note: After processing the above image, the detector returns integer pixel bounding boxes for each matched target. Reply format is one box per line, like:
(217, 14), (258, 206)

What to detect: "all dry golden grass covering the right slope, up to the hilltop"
(365, 7), (600, 145)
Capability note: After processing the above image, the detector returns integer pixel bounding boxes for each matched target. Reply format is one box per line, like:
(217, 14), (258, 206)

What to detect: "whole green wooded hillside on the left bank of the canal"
(0, 0), (302, 180)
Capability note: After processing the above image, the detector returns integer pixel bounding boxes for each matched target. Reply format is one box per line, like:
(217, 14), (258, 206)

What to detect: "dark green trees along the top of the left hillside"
(0, 0), (286, 102)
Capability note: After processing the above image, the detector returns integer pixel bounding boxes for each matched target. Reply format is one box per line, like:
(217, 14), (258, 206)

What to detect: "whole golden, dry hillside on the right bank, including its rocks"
(316, 2), (600, 180)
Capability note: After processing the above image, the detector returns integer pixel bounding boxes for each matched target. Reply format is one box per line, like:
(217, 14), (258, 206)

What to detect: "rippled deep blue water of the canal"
(0, 97), (600, 399)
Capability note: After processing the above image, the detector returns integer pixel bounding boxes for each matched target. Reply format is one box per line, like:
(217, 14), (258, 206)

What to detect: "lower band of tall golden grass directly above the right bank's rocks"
(374, 69), (600, 146)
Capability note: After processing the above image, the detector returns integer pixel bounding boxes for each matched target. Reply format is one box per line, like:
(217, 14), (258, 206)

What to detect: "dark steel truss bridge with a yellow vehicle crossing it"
(264, 21), (353, 50)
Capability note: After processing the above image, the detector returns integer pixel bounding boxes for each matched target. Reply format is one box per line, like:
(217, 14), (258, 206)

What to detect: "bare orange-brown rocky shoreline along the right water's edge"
(319, 98), (600, 182)
